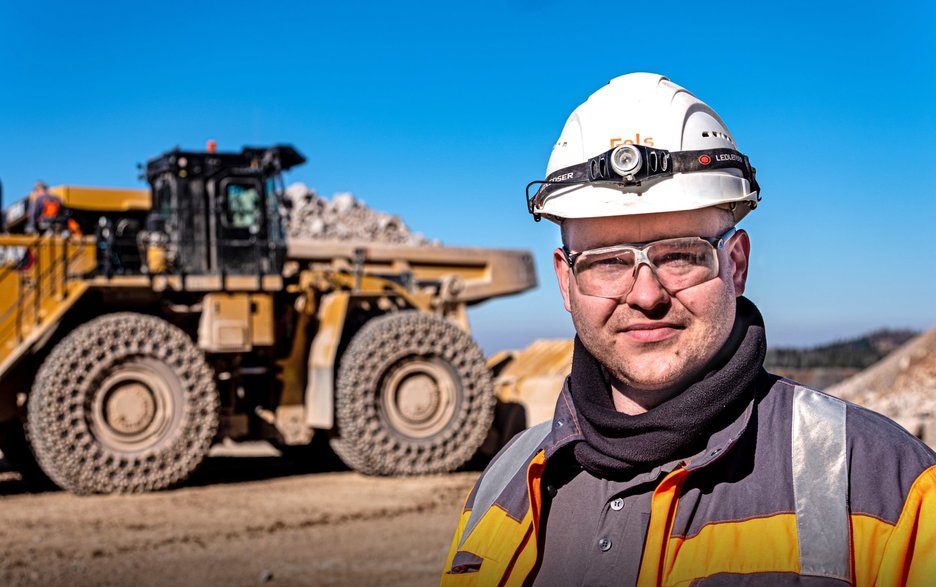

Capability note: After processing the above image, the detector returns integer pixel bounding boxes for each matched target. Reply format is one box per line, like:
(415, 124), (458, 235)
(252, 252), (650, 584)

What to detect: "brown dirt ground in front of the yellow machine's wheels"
(0, 446), (478, 587)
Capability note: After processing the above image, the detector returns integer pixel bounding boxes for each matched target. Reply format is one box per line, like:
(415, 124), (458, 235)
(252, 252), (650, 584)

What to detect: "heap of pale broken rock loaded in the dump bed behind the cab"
(286, 183), (438, 246)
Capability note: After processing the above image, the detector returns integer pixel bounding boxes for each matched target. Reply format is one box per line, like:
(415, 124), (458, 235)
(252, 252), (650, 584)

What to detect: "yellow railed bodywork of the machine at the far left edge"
(0, 235), (96, 377)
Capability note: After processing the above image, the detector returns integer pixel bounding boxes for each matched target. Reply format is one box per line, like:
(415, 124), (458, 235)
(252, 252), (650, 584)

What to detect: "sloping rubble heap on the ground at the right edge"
(826, 328), (936, 446)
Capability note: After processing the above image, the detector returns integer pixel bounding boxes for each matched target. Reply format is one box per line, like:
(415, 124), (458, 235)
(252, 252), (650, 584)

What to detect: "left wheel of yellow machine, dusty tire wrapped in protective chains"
(27, 313), (219, 494)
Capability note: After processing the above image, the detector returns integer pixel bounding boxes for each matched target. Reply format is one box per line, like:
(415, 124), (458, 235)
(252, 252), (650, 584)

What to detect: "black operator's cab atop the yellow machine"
(144, 146), (305, 276)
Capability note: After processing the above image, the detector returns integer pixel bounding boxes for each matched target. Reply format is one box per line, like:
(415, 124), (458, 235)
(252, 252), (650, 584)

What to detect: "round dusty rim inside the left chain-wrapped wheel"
(91, 358), (181, 453)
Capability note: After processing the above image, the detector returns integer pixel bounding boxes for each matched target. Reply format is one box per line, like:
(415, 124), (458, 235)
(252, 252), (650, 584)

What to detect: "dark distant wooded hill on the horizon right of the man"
(764, 329), (919, 369)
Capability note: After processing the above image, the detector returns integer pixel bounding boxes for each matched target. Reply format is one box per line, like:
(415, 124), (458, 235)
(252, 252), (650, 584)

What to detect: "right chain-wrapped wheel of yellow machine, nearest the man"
(332, 311), (495, 475)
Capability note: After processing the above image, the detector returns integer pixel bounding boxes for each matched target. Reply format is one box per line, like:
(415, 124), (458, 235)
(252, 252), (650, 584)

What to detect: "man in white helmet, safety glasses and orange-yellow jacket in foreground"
(442, 74), (936, 586)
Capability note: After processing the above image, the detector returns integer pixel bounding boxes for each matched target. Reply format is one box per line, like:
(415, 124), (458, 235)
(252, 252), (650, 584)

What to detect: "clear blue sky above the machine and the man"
(0, 0), (936, 352)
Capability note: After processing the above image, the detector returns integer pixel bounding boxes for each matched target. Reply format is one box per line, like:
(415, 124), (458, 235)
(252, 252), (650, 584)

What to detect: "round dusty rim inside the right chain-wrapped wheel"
(381, 358), (458, 439)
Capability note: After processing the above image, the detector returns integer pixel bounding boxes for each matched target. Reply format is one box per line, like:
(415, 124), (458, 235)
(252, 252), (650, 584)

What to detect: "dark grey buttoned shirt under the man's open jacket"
(533, 461), (680, 587)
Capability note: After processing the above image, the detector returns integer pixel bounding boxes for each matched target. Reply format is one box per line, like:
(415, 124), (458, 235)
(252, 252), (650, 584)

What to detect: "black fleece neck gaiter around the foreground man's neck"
(569, 297), (767, 479)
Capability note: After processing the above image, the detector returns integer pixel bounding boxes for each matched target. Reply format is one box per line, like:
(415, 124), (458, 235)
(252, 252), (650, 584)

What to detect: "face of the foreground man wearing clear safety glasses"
(553, 208), (750, 391)
